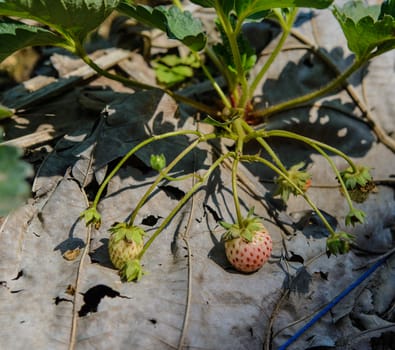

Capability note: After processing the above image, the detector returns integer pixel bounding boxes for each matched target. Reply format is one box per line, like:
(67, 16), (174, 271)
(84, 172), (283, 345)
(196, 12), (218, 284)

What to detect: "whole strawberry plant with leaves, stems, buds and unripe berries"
(0, 0), (395, 281)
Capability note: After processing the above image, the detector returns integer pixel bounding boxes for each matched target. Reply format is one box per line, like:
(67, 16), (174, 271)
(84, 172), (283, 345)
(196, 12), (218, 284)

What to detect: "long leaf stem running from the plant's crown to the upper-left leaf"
(76, 48), (217, 115)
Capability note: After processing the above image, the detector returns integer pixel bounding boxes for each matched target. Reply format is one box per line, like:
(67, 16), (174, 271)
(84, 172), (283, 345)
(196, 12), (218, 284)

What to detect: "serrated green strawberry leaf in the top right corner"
(333, 0), (395, 60)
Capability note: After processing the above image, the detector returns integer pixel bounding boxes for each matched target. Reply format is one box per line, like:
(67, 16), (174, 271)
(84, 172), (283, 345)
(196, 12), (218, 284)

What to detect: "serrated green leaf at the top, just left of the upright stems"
(118, 1), (207, 51)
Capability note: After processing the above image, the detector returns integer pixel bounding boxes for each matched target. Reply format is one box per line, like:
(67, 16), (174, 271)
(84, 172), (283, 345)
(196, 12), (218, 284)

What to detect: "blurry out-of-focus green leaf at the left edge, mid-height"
(0, 130), (33, 216)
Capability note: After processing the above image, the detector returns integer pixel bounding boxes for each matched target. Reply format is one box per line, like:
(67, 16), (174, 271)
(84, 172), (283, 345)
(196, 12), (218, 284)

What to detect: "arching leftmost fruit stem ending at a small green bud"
(92, 130), (206, 208)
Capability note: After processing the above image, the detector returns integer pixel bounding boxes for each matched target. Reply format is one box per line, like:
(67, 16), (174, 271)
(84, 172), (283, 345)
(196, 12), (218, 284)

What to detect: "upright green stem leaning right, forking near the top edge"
(249, 8), (298, 100)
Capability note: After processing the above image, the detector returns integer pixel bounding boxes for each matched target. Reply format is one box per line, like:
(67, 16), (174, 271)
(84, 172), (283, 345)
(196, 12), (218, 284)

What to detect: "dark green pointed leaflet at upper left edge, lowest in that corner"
(0, 21), (67, 62)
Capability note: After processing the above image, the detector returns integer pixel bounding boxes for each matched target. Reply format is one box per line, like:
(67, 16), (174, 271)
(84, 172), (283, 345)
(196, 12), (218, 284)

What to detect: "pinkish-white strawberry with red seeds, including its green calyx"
(222, 209), (273, 273)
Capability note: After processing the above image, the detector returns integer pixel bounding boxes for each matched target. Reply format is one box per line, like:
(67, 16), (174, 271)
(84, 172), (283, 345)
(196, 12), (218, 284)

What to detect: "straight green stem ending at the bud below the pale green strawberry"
(139, 152), (234, 259)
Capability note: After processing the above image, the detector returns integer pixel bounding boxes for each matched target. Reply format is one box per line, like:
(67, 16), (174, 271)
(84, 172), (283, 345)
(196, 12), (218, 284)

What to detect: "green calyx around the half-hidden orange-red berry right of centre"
(274, 162), (311, 202)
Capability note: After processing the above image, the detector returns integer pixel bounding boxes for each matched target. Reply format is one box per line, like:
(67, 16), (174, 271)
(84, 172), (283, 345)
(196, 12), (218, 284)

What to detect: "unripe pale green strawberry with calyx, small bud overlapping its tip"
(108, 222), (145, 280)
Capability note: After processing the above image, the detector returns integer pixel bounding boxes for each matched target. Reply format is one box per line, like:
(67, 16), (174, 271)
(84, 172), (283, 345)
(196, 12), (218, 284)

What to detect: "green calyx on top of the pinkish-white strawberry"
(220, 209), (264, 242)
